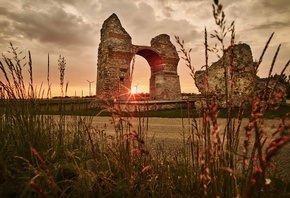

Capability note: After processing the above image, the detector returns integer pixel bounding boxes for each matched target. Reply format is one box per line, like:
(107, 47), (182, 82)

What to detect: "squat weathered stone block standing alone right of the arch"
(194, 44), (286, 108)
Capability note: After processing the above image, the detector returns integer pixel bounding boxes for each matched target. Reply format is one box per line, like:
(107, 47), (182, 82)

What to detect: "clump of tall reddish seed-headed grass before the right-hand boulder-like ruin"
(176, 1), (289, 197)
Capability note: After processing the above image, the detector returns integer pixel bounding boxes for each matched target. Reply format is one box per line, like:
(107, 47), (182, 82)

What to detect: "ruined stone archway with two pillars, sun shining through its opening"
(96, 14), (181, 100)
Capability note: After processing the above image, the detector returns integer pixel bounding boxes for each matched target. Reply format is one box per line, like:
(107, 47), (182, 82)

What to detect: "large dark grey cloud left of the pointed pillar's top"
(8, 7), (94, 46)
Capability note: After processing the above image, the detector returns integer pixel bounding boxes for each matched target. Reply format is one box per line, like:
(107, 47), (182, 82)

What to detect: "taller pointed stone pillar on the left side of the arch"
(97, 14), (133, 100)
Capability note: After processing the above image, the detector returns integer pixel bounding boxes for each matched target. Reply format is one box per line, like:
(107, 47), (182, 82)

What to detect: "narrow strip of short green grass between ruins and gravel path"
(28, 99), (290, 119)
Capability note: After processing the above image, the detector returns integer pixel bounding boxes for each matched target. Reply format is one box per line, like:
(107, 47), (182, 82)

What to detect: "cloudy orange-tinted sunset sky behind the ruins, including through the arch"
(0, 0), (290, 96)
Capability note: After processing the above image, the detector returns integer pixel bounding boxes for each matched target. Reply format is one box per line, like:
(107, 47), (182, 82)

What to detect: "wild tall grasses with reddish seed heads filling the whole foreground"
(0, 1), (290, 197)
